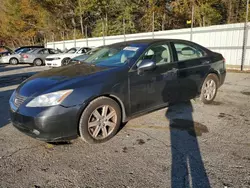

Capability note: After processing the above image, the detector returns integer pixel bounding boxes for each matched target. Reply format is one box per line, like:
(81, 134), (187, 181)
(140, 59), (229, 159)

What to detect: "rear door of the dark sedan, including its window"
(171, 41), (211, 100)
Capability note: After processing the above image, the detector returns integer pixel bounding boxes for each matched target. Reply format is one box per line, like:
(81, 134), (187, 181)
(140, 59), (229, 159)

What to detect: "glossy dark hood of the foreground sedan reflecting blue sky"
(17, 64), (109, 97)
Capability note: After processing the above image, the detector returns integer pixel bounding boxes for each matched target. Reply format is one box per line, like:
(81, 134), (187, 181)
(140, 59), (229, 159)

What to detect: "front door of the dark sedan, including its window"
(129, 43), (179, 114)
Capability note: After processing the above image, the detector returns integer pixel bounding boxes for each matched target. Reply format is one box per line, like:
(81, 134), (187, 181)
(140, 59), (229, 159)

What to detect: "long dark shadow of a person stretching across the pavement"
(166, 101), (211, 188)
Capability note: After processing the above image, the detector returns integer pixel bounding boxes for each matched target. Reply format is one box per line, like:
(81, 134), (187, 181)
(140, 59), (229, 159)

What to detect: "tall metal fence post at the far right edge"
(240, 0), (249, 71)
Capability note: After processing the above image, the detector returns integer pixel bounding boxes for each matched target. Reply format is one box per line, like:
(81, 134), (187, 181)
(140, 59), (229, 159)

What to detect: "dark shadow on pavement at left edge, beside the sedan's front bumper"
(0, 90), (14, 128)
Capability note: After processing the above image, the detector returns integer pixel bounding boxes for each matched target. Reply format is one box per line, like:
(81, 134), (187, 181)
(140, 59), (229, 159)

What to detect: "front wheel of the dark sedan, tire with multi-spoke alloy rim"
(79, 97), (121, 144)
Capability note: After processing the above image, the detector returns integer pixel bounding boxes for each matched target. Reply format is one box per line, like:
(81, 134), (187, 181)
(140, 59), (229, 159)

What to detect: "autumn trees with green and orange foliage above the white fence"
(0, 0), (246, 46)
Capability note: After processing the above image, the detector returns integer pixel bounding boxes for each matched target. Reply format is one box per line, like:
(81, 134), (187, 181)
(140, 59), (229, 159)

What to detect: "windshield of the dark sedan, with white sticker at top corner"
(84, 46), (139, 66)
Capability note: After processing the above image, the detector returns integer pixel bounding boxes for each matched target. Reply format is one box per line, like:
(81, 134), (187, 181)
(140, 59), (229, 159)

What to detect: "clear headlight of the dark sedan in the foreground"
(26, 89), (73, 107)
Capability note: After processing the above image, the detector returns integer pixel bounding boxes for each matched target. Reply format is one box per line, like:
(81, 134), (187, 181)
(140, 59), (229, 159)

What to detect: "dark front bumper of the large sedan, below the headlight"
(10, 102), (81, 142)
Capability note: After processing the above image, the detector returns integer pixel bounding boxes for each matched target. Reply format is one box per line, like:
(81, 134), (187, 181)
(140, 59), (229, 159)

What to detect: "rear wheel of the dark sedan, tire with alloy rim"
(200, 74), (219, 104)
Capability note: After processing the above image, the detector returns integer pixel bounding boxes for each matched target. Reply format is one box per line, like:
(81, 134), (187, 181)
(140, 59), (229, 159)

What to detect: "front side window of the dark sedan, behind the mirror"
(137, 44), (172, 66)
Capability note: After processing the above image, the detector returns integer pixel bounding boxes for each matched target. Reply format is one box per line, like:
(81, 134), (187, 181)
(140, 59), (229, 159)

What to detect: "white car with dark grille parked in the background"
(45, 47), (91, 67)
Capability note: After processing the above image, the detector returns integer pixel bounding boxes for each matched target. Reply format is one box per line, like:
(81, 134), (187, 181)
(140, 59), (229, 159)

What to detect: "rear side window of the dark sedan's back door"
(174, 43), (205, 61)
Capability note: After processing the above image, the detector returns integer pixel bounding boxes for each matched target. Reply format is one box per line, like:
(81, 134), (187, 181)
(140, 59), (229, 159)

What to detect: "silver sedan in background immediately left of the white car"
(20, 48), (60, 66)
